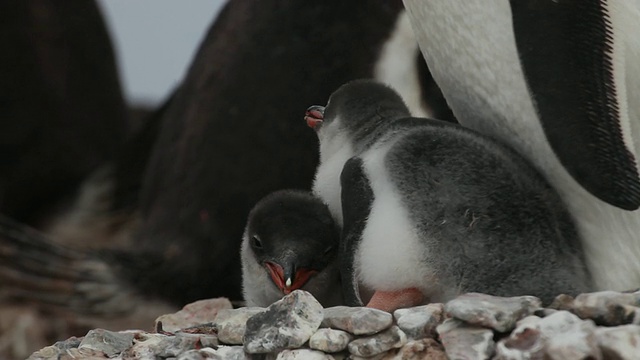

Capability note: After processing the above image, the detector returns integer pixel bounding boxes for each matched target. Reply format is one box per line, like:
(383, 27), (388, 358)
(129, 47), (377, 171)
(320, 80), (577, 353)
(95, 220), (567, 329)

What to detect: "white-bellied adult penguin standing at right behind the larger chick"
(404, 0), (640, 290)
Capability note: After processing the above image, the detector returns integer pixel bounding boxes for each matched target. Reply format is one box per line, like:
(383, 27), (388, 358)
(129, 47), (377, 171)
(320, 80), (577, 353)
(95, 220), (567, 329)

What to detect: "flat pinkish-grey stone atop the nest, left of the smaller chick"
(155, 298), (233, 332)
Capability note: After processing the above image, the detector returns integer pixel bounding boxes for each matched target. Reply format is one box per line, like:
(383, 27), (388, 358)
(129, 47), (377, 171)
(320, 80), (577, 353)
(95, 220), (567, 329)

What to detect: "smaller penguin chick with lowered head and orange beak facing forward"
(241, 190), (343, 307)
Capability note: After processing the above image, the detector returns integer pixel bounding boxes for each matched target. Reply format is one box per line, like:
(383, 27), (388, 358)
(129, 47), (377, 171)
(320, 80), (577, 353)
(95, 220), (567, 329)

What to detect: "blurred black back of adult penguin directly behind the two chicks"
(137, 0), (452, 303)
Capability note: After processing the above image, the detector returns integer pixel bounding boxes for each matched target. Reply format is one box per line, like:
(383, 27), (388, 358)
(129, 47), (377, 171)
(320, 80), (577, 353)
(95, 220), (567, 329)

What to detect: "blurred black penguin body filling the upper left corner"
(0, 0), (129, 225)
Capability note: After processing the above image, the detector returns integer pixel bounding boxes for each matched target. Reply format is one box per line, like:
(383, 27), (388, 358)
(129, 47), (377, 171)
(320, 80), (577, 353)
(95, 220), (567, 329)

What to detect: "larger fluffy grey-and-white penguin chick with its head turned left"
(305, 80), (591, 311)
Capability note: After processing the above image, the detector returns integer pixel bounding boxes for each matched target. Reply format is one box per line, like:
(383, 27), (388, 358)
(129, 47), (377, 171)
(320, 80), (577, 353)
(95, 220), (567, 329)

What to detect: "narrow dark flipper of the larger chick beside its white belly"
(339, 157), (373, 306)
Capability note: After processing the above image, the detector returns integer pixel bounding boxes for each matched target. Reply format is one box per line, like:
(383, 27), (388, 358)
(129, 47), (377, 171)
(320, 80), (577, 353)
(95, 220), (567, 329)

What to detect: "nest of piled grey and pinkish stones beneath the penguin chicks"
(29, 290), (640, 360)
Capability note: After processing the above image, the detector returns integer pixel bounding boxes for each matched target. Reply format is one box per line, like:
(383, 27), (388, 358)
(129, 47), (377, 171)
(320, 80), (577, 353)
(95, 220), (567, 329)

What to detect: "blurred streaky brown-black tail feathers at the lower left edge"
(0, 215), (133, 315)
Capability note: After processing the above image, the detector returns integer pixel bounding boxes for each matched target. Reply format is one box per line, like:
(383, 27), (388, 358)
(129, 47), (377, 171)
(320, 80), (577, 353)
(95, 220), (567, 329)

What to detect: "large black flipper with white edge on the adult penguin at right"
(511, 0), (640, 210)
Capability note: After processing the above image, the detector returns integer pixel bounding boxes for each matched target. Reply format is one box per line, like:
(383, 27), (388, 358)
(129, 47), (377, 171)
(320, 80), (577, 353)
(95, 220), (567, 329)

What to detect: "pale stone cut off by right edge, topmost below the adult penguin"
(571, 291), (640, 326)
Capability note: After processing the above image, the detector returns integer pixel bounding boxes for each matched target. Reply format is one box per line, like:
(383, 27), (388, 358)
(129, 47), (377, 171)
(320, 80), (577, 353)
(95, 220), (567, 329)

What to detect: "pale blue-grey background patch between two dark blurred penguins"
(98, 0), (225, 107)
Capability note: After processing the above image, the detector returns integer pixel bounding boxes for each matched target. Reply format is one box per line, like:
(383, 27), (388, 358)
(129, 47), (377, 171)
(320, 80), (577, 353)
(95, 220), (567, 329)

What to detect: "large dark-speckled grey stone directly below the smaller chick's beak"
(244, 290), (323, 354)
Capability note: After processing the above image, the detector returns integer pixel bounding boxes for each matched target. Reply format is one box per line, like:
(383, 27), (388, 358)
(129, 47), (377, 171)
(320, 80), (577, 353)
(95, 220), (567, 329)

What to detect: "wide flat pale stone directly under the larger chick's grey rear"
(444, 293), (542, 332)
